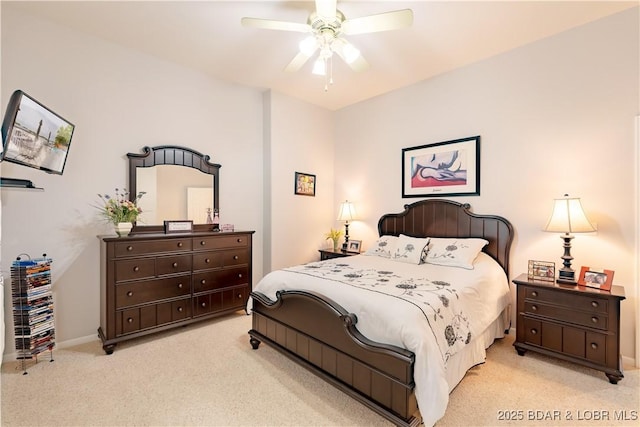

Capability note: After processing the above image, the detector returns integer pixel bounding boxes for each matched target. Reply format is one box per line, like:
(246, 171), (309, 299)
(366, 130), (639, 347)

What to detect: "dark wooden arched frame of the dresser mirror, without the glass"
(127, 145), (221, 233)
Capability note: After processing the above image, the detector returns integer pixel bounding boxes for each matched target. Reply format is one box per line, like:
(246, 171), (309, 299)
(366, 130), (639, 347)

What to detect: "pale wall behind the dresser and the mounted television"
(1, 5), (263, 353)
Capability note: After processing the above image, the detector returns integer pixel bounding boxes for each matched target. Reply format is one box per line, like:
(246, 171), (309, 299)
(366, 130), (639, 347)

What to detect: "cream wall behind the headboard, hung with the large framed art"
(335, 8), (640, 358)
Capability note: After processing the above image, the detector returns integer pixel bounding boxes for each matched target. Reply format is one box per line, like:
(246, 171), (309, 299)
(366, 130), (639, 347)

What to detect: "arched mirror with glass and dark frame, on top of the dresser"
(127, 145), (221, 234)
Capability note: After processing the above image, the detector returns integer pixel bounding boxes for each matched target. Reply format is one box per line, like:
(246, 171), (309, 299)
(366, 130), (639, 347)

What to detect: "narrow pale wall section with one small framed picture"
(264, 93), (339, 273)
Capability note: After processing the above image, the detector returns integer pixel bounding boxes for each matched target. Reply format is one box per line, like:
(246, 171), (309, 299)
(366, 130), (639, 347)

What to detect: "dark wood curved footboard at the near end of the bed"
(249, 291), (420, 426)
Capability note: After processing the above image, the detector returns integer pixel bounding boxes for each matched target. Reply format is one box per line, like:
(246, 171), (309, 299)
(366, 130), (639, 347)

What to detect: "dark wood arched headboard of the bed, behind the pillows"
(378, 199), (513, 277)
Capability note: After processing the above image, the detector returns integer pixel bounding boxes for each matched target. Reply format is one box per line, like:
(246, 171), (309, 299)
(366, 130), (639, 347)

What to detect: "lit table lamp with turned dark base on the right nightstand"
(544, 194), (596, 285)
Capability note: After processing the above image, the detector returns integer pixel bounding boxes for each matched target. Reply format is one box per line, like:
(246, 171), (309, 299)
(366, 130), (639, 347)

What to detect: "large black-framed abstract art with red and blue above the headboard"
(402, 136), (480, 197)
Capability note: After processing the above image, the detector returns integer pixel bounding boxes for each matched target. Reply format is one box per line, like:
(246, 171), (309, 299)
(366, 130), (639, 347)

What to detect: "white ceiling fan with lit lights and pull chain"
(241, 0), (413, 90)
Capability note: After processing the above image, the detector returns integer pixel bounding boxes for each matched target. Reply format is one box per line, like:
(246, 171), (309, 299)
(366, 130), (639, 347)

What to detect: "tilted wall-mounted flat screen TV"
(0, 90), (75, 175)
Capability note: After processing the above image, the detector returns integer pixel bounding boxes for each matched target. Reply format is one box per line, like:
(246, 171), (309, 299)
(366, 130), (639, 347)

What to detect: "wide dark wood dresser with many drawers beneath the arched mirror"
(98, 231), (254, 354)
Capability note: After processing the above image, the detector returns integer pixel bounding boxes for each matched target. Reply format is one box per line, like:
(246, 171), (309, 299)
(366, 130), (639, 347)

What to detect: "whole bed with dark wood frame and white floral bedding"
(247, 199), (514, 426)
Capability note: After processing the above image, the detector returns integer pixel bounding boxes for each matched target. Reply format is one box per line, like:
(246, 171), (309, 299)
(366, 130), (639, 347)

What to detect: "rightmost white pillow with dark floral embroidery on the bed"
(424, 237), (489, 270)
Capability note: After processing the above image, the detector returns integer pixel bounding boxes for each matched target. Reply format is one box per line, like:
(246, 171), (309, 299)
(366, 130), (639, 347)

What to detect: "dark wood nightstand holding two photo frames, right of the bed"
(513, 274), (625, 384)
